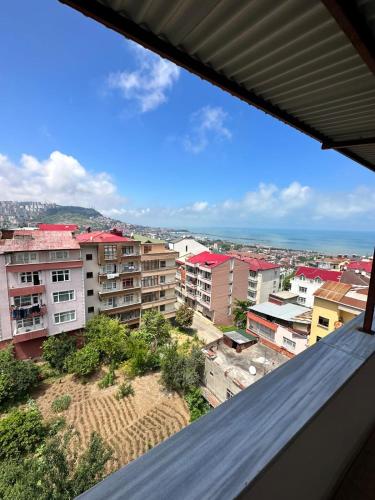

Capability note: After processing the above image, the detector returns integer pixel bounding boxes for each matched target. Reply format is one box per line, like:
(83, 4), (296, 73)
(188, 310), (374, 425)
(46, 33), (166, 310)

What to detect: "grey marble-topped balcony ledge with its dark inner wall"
(79, 315), (375, 500)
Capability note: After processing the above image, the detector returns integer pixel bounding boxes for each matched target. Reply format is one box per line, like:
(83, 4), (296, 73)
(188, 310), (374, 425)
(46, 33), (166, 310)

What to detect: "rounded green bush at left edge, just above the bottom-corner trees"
(0, 407), (48, 460)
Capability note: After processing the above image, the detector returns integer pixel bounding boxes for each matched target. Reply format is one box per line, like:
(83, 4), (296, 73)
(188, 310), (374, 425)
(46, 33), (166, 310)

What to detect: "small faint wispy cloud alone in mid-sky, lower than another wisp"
(183, 106), (232, 154)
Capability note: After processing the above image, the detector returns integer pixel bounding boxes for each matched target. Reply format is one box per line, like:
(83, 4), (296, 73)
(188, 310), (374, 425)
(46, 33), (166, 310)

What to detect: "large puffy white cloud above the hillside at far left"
(0, 151), (126, 209)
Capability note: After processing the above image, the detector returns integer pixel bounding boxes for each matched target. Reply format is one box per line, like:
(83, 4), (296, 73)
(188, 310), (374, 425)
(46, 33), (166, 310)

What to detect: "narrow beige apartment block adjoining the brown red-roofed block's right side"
(134, 235), (178, 318)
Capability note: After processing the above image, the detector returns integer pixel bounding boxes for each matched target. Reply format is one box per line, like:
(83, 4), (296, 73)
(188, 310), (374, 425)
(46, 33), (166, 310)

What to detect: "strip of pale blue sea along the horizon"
(188, 227), (375, 256)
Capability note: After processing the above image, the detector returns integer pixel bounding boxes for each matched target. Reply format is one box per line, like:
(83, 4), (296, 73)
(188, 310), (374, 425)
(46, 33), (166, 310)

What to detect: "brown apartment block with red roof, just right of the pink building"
(76, 230), (141, 327)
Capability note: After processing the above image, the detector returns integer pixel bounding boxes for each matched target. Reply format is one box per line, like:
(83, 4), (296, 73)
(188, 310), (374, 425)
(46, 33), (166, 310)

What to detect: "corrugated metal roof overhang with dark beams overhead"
(60, 0), (375, 171)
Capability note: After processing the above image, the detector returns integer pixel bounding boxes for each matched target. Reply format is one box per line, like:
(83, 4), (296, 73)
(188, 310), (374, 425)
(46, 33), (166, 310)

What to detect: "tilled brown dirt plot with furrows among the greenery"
(34, 374), (189, 470)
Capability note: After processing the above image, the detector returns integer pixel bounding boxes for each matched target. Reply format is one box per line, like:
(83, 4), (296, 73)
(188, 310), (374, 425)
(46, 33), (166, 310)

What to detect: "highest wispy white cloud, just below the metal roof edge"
(107, 43), (180, 113)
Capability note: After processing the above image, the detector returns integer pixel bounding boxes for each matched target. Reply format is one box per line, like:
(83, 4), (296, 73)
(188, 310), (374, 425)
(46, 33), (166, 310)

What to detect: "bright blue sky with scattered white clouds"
(0, 0), (375, 230)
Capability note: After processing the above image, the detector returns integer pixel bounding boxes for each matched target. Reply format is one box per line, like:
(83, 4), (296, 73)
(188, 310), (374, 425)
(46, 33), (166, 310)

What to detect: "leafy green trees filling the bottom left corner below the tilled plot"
(0, 432), (112, 500)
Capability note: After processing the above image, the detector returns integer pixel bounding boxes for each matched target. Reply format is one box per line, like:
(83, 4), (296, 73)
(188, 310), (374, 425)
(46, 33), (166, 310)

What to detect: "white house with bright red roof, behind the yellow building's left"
(290, 266), (342, 307)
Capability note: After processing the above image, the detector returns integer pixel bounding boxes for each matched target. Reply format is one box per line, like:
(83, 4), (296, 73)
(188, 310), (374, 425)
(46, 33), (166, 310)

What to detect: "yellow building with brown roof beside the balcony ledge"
(309, 281), (368, 345)
